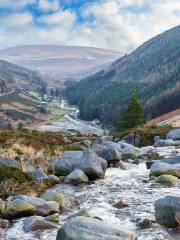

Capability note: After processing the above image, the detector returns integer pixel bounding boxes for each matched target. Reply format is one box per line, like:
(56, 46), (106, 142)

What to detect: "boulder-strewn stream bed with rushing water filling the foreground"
(0, 130), (180, 240)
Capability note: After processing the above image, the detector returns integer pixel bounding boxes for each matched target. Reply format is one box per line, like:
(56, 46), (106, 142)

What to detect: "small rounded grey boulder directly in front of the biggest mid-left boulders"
(65, 169), (89, 184)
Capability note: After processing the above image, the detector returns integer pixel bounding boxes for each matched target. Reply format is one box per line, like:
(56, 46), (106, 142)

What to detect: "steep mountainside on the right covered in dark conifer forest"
(65, 26), (180, 126)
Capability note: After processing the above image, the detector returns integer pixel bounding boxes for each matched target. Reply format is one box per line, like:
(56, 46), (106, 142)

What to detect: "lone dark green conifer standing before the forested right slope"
(119, 89), (145, 130)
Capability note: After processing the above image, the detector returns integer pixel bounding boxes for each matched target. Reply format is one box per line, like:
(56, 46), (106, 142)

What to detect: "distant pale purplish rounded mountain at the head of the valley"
(0, 45), (122, 82)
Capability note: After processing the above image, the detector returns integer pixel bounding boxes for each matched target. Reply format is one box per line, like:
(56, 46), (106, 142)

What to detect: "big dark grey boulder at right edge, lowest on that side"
(155, 196), (180, 228)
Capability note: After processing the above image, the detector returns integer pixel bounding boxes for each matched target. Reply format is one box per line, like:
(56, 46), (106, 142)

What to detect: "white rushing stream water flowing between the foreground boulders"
(0, 147), (180, 240)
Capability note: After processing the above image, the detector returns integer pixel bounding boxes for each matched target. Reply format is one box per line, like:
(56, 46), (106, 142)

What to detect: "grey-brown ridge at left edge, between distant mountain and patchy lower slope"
(0, 60), (46, 94)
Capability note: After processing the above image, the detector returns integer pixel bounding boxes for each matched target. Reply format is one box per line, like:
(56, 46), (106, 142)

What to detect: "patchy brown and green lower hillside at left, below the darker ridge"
(0, 89), (46, 129)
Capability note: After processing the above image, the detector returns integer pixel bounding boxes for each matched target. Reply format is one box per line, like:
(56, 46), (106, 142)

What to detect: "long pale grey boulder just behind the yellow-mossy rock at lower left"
(11, 195), (59, 216)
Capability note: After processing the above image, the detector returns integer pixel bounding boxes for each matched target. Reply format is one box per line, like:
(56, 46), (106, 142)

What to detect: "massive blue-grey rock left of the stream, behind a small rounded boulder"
(52, 150), (107, 180)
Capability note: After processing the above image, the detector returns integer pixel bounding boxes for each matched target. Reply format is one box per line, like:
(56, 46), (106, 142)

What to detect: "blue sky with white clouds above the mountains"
(0, 0), (180, 53)
